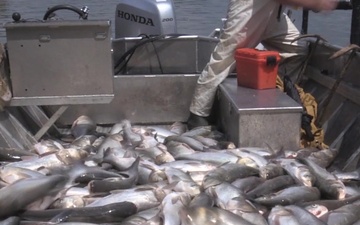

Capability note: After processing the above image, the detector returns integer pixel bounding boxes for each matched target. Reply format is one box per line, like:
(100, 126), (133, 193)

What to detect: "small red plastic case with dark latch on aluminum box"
(235, 48), (280, 89)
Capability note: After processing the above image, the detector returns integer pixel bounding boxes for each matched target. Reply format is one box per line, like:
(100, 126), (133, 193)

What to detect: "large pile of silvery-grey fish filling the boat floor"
(0, 116), (360, 225)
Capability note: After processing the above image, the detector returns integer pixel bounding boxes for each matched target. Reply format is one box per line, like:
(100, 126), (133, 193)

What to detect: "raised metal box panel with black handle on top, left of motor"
(4, 20), (114, 106)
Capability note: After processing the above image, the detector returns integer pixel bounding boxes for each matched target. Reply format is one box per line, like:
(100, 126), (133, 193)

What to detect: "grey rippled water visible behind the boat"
(0, 0), (351, 46)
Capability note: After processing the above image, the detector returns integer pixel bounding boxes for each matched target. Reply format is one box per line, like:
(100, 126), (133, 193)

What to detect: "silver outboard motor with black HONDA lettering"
(115, 0), (177, 38)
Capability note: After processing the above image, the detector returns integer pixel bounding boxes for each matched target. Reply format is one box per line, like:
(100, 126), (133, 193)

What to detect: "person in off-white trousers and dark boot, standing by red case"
(187, 0), (337, 129)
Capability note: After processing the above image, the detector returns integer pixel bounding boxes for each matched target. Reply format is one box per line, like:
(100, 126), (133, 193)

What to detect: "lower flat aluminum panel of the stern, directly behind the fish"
(46, 74), (199, 127)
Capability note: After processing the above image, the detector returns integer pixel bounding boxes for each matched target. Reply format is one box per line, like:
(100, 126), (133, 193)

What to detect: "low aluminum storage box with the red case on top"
(218, 78), (302, 150)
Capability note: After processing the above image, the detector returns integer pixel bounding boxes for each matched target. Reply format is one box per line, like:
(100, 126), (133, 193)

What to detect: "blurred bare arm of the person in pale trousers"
(276, 0), (337, 11)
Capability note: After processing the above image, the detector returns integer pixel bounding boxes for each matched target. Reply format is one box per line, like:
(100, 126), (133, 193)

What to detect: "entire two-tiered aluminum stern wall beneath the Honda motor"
(46, 35), (218, 126)
